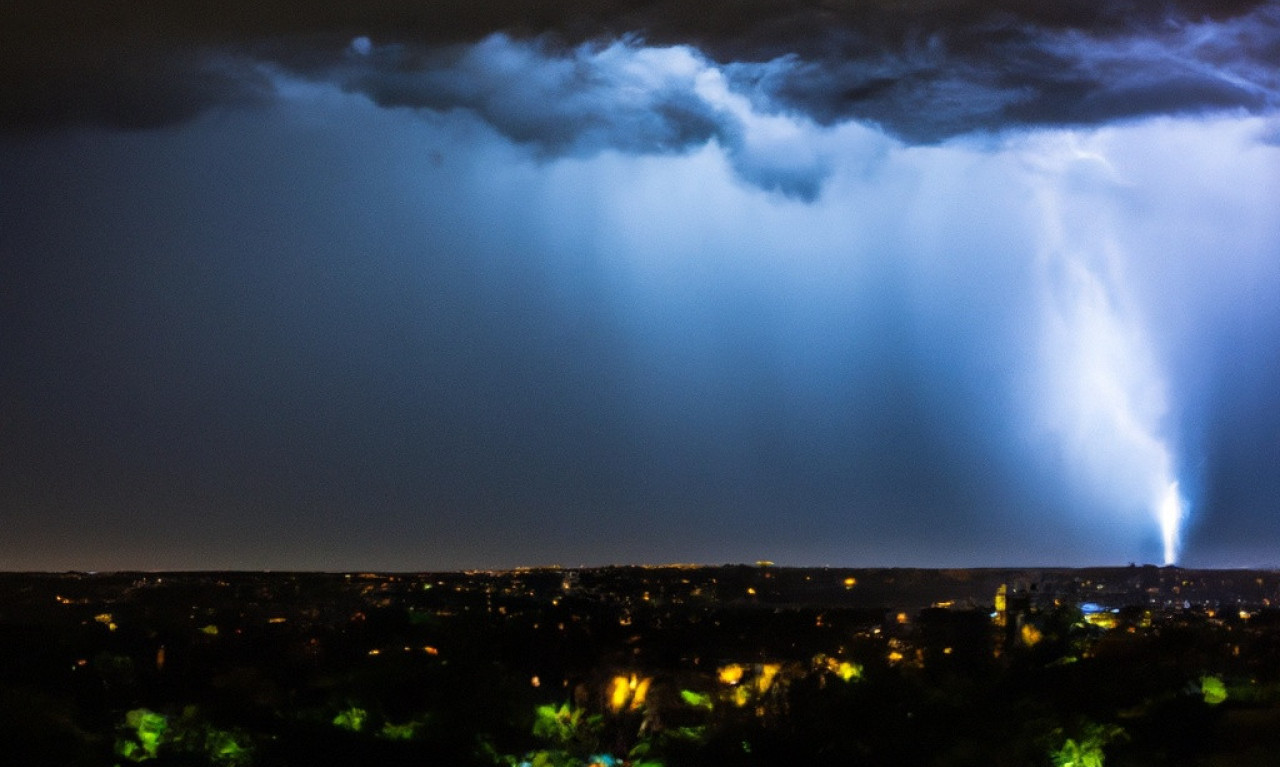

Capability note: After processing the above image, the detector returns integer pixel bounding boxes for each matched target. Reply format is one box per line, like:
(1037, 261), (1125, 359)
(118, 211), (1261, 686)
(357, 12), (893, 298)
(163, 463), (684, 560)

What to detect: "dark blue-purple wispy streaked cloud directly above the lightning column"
(730, 9), (1280, 142)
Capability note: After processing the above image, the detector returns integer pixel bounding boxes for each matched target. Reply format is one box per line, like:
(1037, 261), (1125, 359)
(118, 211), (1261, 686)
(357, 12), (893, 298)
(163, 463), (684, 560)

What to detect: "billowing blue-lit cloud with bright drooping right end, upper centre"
(337, 35), (849, 200)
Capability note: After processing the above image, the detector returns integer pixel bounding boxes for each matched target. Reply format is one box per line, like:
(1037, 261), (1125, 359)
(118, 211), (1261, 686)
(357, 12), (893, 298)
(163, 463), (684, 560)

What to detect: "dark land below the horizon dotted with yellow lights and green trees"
(0, 566), (1280, 767)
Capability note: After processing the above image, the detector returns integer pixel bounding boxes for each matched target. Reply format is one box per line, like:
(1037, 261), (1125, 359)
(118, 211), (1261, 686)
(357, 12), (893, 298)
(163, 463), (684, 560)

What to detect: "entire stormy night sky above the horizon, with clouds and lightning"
(0, 0), (1280, 570)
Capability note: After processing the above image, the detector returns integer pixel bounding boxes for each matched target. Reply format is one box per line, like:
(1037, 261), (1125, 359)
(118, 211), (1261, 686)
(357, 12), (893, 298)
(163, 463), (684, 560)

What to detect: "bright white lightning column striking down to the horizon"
(1028, 132), (1187, 565)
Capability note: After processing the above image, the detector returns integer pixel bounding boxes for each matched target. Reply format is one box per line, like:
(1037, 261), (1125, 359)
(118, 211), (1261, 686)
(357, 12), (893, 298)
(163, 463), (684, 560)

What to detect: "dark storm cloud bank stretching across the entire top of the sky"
(0, 0), (1280, 142)
